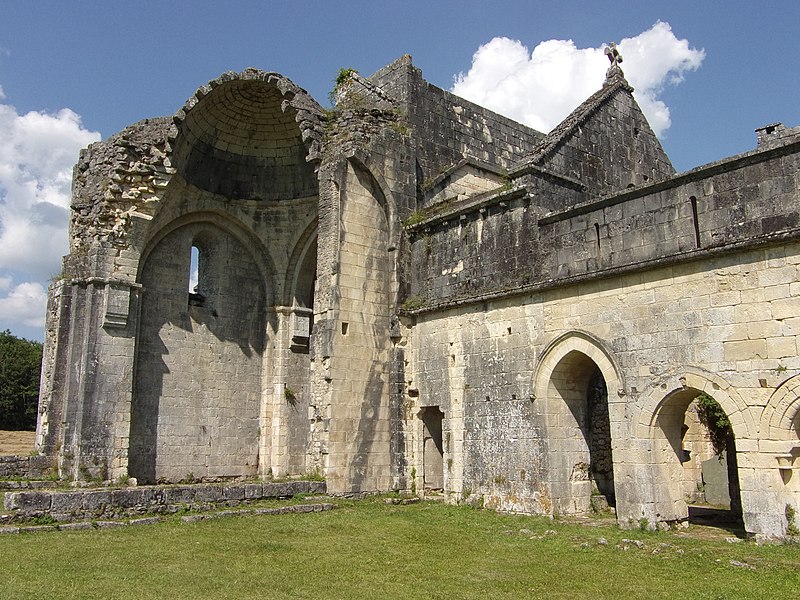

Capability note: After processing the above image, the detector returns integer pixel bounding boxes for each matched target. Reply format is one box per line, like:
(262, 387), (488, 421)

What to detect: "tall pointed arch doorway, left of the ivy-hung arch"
(535, 332), (623, 514)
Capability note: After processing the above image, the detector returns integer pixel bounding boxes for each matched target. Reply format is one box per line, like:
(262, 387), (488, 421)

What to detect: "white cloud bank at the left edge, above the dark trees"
(0, 88), (100, 336)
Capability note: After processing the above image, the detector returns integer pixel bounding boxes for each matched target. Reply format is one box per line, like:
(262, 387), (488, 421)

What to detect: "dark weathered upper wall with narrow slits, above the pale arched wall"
(409, 138), (800, 306)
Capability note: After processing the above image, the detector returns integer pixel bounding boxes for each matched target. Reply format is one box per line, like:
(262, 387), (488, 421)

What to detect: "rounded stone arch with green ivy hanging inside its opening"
(637, 368), (753, 527)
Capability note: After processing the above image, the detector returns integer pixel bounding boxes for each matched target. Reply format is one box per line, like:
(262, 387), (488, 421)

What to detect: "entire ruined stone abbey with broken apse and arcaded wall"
(37, 53), (800, 537)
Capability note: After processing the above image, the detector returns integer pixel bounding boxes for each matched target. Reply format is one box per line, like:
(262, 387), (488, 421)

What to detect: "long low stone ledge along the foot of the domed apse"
(0, 481), (326, 524)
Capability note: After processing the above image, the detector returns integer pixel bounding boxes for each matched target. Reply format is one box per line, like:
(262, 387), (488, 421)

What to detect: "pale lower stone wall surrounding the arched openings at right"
(406, 237), (800, 530)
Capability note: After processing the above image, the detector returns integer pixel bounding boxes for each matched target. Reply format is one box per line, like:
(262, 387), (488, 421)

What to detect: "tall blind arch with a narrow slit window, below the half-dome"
(128, 214), (269, 482)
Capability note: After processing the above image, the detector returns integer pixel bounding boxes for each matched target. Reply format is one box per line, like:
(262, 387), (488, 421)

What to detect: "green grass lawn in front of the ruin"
(0, 499), (800, 600)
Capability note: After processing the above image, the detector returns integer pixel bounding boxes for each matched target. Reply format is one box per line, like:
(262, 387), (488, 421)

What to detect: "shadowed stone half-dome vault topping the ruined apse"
(171, 69), (322, 201)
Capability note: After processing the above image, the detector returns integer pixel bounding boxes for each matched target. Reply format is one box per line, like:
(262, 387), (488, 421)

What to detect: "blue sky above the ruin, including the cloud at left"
(0, 0), (800, 339)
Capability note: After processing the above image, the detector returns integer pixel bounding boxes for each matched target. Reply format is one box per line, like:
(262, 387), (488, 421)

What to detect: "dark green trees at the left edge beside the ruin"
(0, 330), (42, 430)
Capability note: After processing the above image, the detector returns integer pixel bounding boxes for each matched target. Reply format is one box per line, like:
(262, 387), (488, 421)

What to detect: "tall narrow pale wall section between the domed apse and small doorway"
(328, 162), (392, 491)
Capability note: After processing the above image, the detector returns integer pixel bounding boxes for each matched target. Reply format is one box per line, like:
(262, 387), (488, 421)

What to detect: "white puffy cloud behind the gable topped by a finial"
(452, 21), (705, 136)
